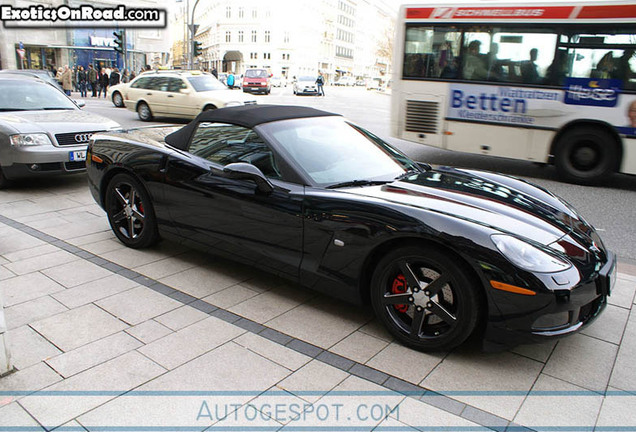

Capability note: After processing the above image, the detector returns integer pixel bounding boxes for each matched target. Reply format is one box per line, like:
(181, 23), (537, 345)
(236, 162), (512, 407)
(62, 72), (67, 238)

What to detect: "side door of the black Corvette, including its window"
(165, 122), (304, 278)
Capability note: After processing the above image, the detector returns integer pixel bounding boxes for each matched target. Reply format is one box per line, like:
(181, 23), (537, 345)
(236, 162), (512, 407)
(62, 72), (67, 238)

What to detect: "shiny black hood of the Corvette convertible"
(347, 167), (593, 246)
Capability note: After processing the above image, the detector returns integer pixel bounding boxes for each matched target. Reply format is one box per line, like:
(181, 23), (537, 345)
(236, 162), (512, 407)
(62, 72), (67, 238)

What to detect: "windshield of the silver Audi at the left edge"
(0, 80), (78, 111)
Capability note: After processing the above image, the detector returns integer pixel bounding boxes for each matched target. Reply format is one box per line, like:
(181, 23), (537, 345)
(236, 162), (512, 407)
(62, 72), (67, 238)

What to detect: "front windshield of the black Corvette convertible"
(260, 116), (419, 187)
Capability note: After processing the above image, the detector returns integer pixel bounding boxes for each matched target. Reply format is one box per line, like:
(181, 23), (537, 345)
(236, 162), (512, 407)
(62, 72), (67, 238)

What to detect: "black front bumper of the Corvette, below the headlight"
(484, 252), (616, 351)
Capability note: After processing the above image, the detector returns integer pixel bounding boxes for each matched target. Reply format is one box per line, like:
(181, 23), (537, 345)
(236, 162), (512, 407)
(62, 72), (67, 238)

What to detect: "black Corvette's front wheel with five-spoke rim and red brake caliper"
(371, 247), (482, 351)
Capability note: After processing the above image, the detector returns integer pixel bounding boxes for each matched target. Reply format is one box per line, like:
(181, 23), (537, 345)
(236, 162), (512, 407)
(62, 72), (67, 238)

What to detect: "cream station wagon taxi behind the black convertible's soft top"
(123, 71), (256, 121)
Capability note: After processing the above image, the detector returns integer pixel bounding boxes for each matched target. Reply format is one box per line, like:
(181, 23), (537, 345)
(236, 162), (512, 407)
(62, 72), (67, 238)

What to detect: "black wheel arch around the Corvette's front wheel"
(359, 237), (488, 308)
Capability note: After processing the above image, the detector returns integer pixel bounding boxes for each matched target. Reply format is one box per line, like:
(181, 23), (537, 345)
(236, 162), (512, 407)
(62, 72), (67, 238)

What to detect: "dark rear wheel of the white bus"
(554, 126), (618, 184)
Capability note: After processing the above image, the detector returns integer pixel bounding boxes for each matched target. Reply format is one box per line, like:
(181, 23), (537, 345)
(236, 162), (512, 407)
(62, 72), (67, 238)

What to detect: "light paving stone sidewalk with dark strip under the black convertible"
(0, 178), (636, 431)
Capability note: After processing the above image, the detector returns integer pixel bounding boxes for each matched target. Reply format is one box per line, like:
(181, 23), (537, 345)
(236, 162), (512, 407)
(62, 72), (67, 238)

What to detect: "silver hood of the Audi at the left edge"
(0, 109), (120, 135)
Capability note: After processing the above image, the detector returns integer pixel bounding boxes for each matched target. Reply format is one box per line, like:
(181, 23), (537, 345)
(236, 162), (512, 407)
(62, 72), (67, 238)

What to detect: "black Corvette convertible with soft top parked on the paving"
(88, 105), (616, 351)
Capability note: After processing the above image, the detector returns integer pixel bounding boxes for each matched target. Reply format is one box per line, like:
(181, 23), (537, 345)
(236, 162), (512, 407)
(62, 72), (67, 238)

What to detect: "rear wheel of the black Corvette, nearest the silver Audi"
(105, 174), (159, 249)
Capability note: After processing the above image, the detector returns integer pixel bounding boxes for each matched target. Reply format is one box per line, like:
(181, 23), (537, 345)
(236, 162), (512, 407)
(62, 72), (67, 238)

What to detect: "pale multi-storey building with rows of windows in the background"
(181, 0), (397, 82)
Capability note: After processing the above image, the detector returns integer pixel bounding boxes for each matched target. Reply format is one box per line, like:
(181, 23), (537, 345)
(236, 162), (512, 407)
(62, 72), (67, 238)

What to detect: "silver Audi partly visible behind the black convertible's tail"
(0, 74), (119, 189)
